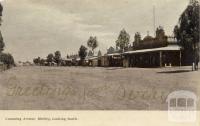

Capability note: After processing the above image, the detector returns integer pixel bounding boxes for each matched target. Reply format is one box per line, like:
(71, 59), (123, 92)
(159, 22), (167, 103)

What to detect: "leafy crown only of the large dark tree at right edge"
(174, 0), (199, 49)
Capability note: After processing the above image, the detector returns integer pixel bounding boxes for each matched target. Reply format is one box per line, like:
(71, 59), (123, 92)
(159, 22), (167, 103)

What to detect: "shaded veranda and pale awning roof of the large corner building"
(123, 45), (181, 67)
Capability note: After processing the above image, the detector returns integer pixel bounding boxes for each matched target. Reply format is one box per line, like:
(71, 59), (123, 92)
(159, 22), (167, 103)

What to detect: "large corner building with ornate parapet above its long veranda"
(122, 27), (182, 67)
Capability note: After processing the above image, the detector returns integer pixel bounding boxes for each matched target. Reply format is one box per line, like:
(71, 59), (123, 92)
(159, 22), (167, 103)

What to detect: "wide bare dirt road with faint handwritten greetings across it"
(0, 66), (200, 110)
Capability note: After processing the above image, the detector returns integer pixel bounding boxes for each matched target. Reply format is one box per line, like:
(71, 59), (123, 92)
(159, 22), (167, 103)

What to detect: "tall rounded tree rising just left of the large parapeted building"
(116, 29), (130, 50)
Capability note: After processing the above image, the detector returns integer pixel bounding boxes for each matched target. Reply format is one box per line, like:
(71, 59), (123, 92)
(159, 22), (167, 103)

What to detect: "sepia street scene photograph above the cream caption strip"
(0, 0), (200, 115)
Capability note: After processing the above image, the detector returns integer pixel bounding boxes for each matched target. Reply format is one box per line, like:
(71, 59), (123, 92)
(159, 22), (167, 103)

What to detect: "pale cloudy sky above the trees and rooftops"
(0, 0), (189, 61)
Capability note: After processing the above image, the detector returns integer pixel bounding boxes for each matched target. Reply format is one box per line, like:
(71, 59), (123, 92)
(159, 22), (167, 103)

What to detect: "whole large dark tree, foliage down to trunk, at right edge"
(174, 0), (200, 67)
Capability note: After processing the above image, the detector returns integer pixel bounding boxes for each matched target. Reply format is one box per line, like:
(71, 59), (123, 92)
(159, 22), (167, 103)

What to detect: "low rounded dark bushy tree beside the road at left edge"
(0, 53), (15, 68)
